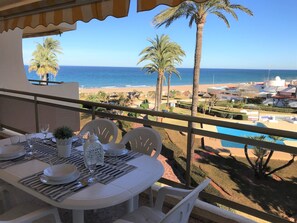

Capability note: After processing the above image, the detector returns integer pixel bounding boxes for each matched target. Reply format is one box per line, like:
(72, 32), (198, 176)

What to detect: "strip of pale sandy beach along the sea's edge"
(79, 83), (240, 94)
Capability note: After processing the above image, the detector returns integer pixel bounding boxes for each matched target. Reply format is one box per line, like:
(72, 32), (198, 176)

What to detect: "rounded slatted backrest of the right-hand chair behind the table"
(121, 127), (162, 158)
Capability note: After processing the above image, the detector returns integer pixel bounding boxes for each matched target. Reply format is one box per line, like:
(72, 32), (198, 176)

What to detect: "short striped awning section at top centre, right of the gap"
(137, 0), (208, 12)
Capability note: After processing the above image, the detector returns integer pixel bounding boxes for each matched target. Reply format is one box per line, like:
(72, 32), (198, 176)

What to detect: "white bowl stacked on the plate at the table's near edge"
(43, 164), (77, 181)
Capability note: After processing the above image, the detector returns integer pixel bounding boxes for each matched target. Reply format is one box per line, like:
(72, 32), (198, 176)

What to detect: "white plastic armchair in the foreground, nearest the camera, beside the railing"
(114, 179), (210, 223)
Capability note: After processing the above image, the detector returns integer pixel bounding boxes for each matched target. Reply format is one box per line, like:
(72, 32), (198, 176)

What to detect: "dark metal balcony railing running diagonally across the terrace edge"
(0, 89), (297, 223)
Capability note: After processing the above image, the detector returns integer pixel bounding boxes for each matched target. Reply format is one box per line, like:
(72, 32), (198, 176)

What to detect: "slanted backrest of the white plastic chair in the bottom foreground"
(161, 179), (210, 223)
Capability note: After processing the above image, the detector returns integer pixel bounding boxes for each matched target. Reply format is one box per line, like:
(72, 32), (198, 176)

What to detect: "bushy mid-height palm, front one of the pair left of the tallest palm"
(137, 35), (185, 111)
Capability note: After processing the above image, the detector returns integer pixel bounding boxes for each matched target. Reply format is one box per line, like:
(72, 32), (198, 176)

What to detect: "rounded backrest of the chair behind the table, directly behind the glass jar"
(79, 118), (118, 144)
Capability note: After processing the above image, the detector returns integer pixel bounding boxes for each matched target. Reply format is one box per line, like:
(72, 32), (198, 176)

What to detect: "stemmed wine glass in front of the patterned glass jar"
(84, 146), (100, 184)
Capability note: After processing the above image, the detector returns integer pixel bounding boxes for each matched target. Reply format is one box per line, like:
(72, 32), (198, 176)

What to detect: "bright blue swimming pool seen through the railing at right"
(217, 122), (295, 148)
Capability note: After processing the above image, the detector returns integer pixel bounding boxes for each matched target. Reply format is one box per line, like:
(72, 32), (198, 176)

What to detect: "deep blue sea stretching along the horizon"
(25, 65), (297, 88)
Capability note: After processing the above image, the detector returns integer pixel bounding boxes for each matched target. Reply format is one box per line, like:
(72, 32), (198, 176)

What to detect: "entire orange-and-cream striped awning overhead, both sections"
(0, 0), (207, 33)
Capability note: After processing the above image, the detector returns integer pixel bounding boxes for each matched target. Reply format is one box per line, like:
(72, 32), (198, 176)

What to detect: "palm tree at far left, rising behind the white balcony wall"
(29, 37), (62, 84)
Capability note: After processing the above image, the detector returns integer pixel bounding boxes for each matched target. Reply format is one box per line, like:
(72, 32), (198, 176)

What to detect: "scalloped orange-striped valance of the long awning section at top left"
(0, 0), (130, 33)
